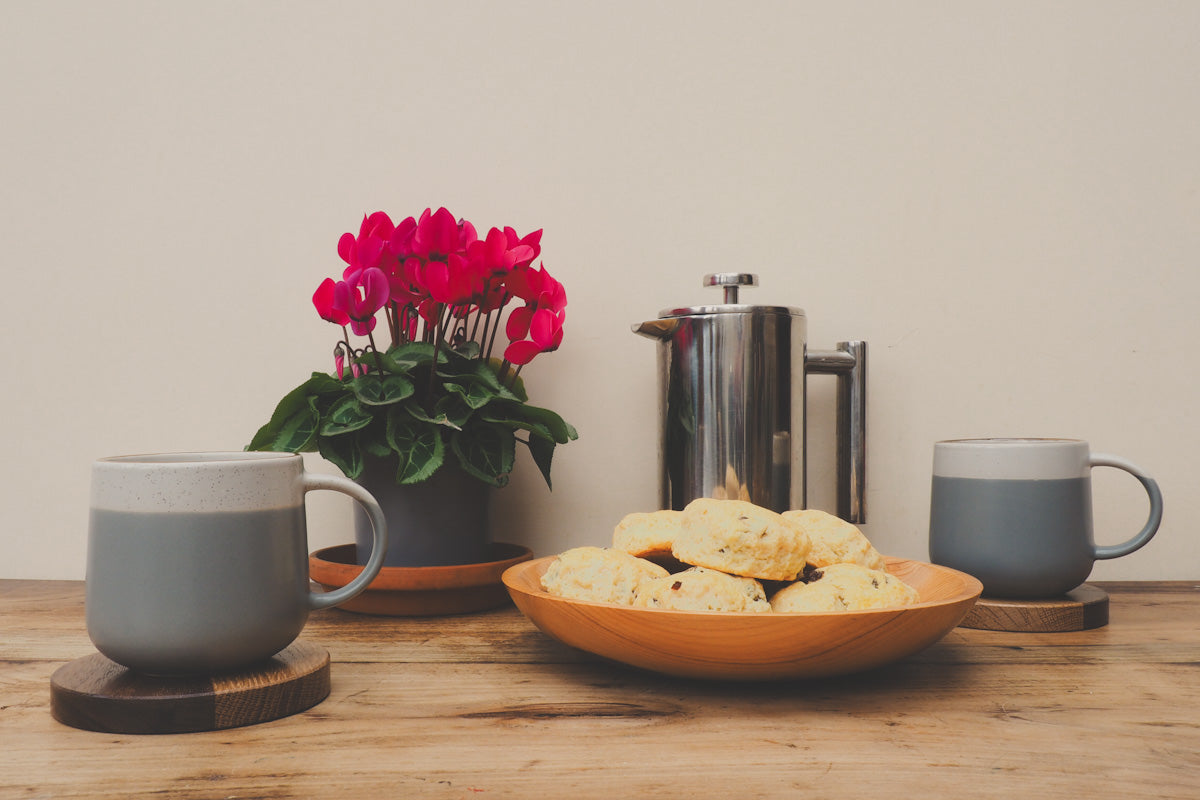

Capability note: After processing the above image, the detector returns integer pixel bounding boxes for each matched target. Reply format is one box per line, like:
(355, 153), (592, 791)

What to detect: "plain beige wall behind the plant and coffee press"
(0, 0), (1200, 579)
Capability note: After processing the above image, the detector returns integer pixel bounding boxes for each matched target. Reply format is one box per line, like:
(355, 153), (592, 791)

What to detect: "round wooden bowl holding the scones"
(503, 557), (983, 680)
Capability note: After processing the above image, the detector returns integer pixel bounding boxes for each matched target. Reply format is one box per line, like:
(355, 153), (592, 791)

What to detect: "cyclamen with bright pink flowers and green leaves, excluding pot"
(247, 209), (578, 486)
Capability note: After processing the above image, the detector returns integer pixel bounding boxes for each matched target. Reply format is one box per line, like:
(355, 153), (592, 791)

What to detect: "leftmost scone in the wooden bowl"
(541, 547), (670, 606)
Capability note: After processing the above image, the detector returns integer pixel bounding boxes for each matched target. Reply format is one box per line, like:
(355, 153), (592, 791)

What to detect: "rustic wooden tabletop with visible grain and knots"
(0, 581), (1200, 800)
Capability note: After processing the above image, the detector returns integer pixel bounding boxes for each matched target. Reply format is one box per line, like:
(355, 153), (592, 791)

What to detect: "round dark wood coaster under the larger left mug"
(50, 642), (329, 733)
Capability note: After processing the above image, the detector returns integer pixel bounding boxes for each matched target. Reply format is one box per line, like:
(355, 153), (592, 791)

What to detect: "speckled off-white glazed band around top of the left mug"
(91, 451), (304, 513)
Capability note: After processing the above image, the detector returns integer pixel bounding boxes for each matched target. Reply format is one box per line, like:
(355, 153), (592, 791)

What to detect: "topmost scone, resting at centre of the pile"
(671, 498), (809, 581)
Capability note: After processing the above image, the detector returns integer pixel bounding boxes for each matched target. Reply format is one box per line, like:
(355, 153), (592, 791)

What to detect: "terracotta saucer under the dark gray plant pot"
(308, 542), (533, 616)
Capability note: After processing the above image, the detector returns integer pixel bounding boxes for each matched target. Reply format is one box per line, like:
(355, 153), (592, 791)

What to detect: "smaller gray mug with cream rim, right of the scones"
(929, 439), (1163, 599)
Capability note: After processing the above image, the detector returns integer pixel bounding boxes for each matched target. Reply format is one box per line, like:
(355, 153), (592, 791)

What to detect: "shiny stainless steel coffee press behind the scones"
(634, 272), (866, 523)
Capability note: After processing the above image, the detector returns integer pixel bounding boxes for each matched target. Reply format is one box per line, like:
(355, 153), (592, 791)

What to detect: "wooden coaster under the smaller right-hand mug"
(959, 583), (1109, 633)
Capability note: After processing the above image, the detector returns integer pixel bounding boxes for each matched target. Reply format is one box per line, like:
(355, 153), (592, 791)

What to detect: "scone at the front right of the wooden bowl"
(770, 564), (920, 612)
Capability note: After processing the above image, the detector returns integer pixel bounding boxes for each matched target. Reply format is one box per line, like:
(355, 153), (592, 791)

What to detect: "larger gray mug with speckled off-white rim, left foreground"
(86, 452), (388, 675)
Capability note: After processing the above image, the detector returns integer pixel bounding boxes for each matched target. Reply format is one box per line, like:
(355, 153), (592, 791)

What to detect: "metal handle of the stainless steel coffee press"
(804, 341), (866, 523)
